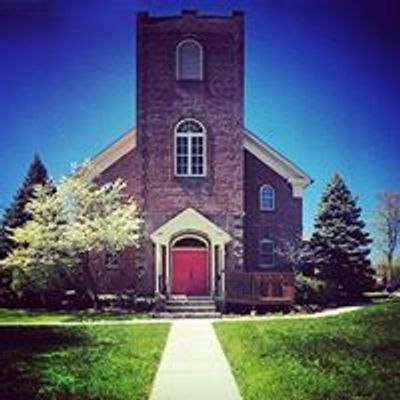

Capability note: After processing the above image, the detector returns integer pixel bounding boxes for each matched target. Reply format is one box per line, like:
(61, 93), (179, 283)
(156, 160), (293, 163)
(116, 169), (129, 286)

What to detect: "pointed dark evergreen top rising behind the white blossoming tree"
(0, 154), (49, 260)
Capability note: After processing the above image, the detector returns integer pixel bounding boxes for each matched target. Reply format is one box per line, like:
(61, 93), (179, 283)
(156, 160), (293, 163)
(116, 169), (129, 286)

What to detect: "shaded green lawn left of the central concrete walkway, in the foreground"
(0, 324), (169, 400)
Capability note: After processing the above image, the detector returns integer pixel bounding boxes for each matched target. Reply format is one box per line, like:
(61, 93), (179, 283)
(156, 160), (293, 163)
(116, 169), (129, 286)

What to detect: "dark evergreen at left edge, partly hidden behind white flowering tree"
(0, 155), (50, 304)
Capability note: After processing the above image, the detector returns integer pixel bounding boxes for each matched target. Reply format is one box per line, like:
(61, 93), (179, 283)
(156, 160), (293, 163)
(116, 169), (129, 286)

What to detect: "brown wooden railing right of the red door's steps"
(225, 272), (295, 305)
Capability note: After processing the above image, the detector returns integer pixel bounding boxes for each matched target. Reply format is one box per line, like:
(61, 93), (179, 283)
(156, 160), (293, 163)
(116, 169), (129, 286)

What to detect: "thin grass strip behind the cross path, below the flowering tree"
(0, 308), (147, 323)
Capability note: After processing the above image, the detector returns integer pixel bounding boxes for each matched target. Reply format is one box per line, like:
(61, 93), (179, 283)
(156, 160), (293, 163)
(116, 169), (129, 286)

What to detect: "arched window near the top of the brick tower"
(176, 39), (203, 81)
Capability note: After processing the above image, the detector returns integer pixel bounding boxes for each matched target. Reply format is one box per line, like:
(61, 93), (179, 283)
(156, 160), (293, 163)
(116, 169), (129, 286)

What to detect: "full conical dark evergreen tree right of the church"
(308, 174), (373, 300)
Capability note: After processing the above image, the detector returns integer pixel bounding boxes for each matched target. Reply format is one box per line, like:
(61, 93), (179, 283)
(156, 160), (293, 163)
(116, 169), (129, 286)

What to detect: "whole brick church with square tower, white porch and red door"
(85, 11), (311, 304)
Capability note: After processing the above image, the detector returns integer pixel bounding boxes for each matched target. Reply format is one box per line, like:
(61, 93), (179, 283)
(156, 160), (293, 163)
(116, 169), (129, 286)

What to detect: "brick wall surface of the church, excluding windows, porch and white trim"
(88, 12), (310, 295)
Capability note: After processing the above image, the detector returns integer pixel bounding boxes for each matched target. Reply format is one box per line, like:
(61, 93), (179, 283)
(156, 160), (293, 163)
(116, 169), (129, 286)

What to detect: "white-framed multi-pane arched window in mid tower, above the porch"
(175, 118), (207, 177)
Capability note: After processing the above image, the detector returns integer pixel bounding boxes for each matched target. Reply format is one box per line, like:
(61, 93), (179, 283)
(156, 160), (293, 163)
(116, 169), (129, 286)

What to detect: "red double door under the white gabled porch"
(171, 248), (209, 296)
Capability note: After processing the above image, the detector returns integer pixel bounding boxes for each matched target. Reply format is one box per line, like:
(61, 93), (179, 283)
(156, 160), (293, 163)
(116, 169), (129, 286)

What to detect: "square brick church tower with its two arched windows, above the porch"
(137, 11), (243, 231)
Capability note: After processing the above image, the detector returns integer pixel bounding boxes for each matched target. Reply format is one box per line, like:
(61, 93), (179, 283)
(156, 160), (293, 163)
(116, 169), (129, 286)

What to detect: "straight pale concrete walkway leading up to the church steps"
(150, 320), (241, 400)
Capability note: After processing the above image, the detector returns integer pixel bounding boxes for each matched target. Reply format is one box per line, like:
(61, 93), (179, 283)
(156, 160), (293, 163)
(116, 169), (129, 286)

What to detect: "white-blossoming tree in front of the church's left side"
(1, 166), (141, 308)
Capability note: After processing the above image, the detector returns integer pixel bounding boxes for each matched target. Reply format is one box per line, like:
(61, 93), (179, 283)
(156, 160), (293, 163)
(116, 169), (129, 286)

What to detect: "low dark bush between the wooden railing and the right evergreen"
(295, 274), (329, 306)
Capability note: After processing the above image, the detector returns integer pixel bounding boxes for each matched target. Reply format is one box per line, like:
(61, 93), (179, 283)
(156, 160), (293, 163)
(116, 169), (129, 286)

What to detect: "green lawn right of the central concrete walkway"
(215, 301), (400, 400)
